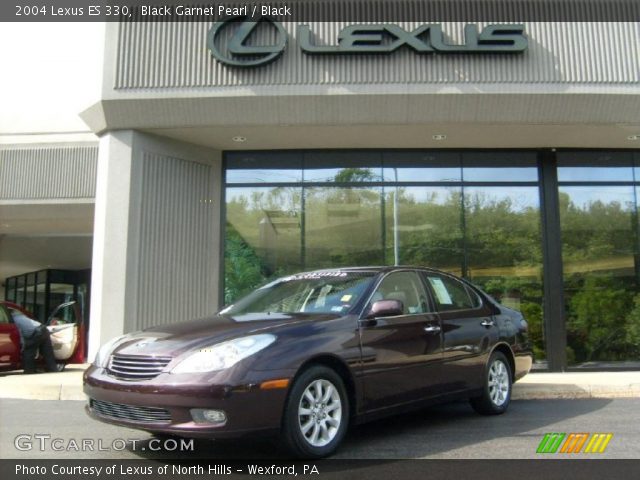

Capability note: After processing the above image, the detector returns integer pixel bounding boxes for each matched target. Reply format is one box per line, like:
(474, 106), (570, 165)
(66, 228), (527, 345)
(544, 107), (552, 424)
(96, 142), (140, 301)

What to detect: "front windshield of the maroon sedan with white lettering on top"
(220, 271), (375, 321)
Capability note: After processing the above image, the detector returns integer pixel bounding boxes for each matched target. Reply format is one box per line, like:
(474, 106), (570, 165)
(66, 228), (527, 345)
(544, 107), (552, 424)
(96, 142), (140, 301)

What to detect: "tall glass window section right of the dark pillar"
(558, 152), (640, 367)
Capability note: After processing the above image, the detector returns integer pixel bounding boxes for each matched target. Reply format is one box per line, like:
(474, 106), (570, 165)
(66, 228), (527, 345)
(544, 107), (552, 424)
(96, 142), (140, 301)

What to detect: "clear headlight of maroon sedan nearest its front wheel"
(171, 333), (276, 373)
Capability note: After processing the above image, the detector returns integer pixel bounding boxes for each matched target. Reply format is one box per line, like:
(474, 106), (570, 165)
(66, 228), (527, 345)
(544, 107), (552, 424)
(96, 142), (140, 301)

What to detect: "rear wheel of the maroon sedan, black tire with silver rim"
(469, 352), (512, 415)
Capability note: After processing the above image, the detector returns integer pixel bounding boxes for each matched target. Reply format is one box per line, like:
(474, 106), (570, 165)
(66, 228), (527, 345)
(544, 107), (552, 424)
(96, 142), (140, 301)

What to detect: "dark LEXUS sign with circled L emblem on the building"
(207, 17), (528, 67)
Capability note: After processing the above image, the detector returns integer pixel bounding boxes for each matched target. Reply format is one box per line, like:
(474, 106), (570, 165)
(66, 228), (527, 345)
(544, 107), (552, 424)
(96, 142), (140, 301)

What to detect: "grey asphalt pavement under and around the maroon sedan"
(0, 398), (640, 460)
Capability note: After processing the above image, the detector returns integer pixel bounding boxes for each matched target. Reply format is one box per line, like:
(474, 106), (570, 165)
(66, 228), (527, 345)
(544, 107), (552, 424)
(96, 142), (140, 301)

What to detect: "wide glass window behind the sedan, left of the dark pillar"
(224, 151), (545, 360)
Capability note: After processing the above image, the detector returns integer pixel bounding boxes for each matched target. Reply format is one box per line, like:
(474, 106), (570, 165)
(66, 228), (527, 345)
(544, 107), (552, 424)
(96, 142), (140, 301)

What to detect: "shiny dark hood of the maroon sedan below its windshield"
(112, 313), (339, 357)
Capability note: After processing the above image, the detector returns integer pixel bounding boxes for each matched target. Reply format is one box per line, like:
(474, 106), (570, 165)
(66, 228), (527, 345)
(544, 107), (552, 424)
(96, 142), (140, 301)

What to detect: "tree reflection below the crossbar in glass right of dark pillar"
(560, 186), (639, 364)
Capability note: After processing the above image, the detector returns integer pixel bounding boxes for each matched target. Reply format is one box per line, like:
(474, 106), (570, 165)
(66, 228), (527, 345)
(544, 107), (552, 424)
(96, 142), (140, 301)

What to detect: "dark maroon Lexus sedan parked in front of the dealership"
(84, 267), (532, 457)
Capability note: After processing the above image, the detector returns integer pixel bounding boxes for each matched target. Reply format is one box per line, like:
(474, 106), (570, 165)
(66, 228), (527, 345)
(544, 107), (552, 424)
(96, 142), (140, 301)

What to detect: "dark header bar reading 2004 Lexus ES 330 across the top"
(0, 0), (640, 22)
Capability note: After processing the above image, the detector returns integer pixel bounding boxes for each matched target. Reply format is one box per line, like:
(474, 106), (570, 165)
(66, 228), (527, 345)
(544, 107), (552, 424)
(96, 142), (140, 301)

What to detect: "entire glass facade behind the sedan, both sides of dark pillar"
(224, 150), (640, 369)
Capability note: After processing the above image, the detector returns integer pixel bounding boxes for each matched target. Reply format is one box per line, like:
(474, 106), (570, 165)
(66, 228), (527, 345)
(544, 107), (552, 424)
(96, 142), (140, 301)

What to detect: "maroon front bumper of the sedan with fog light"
(84, 365), (295, 438)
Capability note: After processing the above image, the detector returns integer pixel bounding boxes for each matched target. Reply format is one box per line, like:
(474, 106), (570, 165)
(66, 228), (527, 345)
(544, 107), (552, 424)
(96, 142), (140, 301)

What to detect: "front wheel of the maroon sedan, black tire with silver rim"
(282, 365), (349, 459)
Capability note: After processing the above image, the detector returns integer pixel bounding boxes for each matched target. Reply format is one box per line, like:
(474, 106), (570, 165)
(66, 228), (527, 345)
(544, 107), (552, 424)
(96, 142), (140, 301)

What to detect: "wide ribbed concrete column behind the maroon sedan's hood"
(88, 130), (222, 360)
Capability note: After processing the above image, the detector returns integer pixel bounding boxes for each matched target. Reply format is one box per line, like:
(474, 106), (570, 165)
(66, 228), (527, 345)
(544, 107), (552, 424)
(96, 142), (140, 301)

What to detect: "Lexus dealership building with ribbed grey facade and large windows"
(0, 2), (640, 371)
